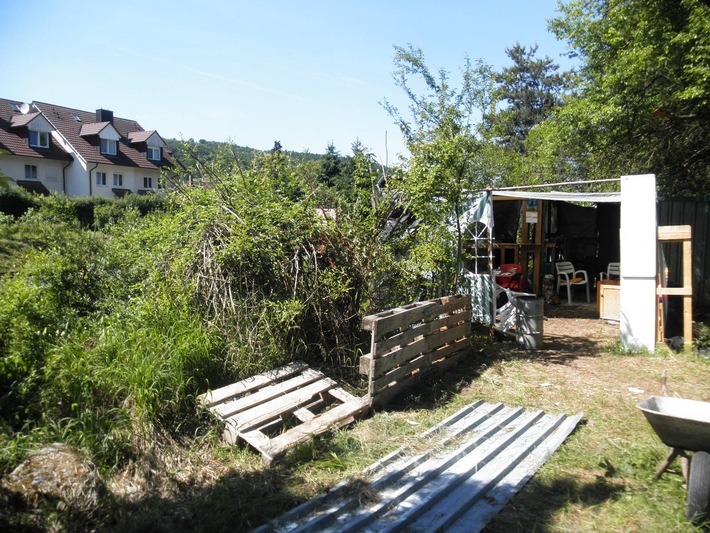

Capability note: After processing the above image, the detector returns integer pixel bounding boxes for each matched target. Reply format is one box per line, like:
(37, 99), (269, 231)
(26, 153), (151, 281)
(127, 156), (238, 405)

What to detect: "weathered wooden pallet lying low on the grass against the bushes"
(199, 362), (370, 465)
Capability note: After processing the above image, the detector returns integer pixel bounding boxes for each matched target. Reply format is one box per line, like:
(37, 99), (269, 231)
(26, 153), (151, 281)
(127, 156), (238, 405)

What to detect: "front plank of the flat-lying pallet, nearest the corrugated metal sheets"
(262, 397), (370, 462)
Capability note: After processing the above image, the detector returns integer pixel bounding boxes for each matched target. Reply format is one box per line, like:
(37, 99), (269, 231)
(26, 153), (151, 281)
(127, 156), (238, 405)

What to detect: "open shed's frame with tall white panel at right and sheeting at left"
(464, 174), (658, 352)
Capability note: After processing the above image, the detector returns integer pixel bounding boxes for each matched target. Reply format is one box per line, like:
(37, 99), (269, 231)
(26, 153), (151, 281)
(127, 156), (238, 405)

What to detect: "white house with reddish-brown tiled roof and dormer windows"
(0, 99), (182, 198)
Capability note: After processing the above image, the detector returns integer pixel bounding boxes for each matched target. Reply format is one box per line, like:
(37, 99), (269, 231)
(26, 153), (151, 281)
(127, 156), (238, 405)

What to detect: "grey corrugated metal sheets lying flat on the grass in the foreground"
(255, 401), (582, 533)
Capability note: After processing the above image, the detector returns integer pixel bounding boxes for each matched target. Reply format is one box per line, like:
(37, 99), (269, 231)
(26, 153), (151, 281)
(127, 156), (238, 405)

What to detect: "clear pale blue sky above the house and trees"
(0, 0), (570, 163)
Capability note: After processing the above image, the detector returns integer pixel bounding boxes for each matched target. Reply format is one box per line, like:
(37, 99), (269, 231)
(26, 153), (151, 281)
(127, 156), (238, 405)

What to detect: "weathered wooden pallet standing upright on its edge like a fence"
(360, 295), (471, 407)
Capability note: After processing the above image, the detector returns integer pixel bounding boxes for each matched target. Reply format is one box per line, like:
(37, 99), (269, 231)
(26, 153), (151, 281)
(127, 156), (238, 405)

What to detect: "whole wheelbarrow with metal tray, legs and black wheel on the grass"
(636, 396), (710, 522)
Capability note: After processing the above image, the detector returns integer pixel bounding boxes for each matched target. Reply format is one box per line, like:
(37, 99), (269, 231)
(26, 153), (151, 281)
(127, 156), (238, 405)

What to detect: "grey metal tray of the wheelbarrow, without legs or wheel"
(636, 396), (710, 453)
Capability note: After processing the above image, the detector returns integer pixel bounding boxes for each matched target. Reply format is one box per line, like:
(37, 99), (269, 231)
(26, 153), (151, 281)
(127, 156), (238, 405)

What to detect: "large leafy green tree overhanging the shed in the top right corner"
(530, 0), (710, 197)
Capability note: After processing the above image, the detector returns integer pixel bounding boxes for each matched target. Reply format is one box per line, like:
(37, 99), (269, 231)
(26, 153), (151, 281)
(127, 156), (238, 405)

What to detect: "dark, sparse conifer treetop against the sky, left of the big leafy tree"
(488, 43), (568, 154)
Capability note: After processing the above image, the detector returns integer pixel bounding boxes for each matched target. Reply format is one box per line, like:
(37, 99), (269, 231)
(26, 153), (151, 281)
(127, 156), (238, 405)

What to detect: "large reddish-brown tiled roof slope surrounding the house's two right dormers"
(33, 102), (179, 169)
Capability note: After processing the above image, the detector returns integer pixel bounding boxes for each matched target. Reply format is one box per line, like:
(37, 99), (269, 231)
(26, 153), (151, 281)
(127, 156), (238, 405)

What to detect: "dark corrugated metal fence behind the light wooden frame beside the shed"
(660, 200), (710, 313)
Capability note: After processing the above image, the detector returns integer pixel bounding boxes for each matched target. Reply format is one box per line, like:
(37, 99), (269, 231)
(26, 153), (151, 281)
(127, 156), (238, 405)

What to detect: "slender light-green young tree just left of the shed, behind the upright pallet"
(384, 45), (491, 295)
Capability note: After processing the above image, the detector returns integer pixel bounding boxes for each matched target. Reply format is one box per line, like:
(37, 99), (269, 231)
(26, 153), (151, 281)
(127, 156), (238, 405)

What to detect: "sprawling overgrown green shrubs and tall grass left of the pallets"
(0, 144), (412, 467)
